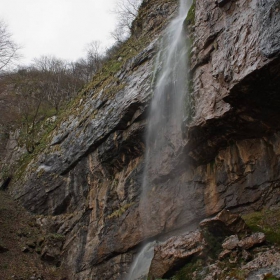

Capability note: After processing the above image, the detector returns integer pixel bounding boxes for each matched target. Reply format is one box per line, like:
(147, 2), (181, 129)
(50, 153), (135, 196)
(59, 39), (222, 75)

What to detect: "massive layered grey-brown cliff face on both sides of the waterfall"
(4, 0), (280, 280)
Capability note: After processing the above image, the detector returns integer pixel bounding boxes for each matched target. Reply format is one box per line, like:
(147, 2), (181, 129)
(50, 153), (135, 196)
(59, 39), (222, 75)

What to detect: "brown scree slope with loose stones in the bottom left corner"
(0, 191), (67, 280)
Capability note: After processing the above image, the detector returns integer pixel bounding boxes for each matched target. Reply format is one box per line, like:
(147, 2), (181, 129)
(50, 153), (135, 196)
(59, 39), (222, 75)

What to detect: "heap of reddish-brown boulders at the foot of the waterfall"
(149, 211), (277, 280)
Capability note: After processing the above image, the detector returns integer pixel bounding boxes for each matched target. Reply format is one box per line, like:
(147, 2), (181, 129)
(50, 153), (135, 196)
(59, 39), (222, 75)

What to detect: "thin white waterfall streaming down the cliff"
(126, 0), (192, 280)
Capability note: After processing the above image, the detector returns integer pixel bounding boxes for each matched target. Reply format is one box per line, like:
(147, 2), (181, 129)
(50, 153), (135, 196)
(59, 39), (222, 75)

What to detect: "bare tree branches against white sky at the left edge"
(0, 21), (19, 73)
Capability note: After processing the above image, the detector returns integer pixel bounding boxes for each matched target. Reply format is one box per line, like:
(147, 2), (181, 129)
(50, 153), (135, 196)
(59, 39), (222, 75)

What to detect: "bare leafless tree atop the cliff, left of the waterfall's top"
(111, 0), (142, 42)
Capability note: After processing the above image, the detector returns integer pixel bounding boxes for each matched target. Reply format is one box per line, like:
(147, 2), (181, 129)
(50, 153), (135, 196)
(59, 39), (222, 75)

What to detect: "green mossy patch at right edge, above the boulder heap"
(242, 209), (280, 245)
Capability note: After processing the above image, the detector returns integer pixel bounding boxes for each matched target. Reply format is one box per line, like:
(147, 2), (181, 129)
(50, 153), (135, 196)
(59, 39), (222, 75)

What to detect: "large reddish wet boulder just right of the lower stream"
(149, 231), (205, 278)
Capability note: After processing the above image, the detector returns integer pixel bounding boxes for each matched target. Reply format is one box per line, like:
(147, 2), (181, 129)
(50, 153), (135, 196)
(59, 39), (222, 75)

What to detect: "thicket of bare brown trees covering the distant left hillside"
(0, 57), (84, 153)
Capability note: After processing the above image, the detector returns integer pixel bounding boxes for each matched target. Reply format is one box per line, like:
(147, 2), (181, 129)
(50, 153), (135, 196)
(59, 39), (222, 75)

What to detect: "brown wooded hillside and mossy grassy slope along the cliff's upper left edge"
(0, 0), (176, 187)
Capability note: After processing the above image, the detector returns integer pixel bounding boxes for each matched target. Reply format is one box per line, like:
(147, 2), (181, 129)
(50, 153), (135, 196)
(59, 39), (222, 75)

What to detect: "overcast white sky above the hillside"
(0, 0), (116, 63)
